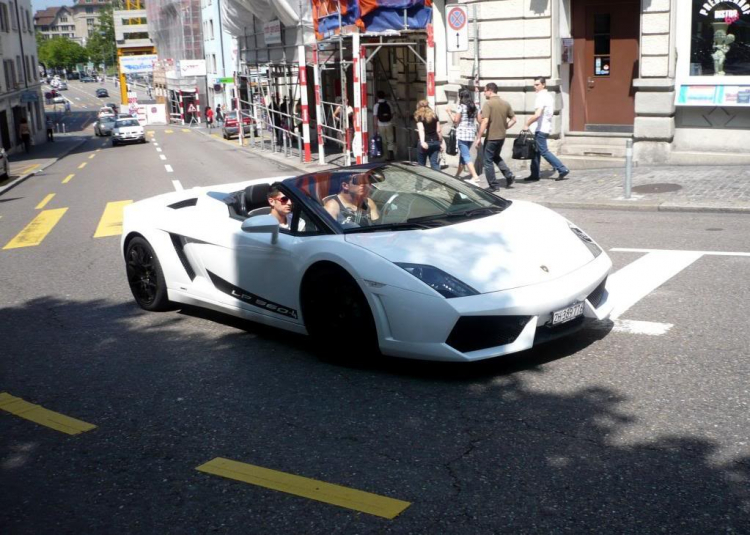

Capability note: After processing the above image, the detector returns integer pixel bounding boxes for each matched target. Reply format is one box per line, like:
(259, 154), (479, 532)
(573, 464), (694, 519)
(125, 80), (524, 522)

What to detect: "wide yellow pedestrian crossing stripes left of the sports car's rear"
(2, 201), (133, 250)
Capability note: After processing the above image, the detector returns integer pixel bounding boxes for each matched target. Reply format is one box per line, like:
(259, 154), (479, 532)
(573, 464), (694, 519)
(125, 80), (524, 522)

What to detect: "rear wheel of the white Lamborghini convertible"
(125, 236), (171, 312)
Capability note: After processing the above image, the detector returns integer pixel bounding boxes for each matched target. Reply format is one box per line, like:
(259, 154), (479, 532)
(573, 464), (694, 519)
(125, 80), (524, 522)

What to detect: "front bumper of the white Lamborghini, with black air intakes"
(371, 254), (613, 362)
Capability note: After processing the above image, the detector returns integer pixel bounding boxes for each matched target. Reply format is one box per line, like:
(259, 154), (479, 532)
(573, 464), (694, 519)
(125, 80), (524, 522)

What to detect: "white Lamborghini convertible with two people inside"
(122, 164), (612, 361)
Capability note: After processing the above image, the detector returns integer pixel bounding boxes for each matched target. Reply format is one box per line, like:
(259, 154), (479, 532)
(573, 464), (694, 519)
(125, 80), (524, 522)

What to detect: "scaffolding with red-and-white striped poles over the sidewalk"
(234, 0), (435, 165)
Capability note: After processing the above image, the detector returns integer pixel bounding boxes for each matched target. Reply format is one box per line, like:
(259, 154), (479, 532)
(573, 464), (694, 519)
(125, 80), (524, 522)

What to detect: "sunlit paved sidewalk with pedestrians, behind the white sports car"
(196, 129), (750, 214)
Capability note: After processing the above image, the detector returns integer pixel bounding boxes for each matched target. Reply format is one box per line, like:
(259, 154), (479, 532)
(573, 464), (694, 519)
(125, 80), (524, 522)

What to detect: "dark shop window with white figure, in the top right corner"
(689, 0), (750, 76)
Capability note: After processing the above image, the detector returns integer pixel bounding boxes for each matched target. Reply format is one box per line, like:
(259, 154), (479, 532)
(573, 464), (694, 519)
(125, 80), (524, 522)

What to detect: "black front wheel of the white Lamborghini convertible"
(301, 266), (380, 364)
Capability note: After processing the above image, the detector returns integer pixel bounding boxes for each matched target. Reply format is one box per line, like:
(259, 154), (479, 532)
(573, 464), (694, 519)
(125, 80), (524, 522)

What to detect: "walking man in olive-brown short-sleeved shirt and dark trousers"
(474, 83), (516, 191)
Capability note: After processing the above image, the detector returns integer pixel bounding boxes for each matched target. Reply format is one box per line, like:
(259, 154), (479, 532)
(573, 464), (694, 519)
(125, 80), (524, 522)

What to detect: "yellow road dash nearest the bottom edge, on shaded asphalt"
(196, 457), (411, 519)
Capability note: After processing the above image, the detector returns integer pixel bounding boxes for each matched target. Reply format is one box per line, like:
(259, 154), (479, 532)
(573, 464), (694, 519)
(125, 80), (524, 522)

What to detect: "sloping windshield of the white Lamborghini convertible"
(284, 164), (510, 233)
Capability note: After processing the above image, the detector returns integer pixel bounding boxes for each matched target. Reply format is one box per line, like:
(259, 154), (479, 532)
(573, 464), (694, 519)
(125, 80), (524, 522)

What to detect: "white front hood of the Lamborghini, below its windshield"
(346, 201), (594, 293)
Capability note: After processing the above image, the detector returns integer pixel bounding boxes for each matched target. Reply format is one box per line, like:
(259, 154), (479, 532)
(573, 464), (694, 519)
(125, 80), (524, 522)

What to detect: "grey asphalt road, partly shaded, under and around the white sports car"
(0, 122), (750, 534)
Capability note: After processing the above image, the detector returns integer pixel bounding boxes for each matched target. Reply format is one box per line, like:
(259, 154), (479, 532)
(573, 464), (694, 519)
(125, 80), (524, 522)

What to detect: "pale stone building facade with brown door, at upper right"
(434, 0), (750, 167)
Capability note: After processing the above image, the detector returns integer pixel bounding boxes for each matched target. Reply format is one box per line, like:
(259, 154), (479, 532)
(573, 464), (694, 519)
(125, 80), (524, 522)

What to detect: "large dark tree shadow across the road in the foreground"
(0, 296), (750, 534)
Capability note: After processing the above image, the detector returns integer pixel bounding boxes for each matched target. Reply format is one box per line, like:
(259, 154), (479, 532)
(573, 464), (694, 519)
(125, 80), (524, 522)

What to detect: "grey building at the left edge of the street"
(0, 0), (46, 152)
